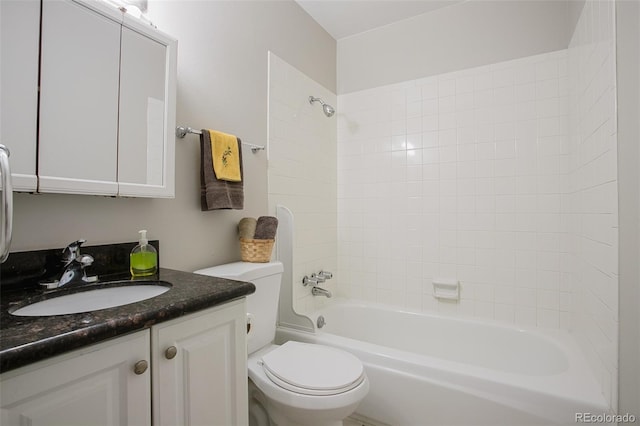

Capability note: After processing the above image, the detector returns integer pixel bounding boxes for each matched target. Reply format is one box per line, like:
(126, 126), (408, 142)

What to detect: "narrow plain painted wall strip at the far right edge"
(616, 1), (640, 418)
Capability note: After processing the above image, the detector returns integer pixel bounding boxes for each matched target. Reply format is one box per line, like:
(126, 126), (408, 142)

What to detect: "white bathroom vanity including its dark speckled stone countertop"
(0, 269), (255, 426)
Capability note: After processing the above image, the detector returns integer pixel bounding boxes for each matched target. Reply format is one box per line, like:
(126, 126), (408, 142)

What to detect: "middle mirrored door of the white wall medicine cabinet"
(38, 0), (121, 195)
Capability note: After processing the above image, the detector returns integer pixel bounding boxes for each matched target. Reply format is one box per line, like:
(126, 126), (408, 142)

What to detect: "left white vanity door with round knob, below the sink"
(0, 330), (151, 426)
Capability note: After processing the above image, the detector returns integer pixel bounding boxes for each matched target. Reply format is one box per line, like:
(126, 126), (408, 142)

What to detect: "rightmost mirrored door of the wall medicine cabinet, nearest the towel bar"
(118, 23), (176, 197)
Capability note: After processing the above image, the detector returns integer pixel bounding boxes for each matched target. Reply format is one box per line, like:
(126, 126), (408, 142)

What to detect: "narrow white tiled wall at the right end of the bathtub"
(563, 0), (618, 409)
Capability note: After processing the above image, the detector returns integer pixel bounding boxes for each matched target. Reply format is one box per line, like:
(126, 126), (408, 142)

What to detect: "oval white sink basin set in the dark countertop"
(11, 284), (171, 317)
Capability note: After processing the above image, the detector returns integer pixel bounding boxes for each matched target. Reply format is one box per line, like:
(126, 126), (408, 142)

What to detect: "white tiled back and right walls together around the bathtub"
(337, 1), (618, 407)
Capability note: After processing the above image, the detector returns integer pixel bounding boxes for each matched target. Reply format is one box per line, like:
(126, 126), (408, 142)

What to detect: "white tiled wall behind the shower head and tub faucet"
(268, 53), (337, 313)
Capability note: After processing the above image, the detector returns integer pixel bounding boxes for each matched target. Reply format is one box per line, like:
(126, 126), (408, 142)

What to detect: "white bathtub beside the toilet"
(278, 302), (608, 426)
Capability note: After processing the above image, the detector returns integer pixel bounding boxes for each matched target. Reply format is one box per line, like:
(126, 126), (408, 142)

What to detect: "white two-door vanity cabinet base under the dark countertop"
(0, 298), (248, 426)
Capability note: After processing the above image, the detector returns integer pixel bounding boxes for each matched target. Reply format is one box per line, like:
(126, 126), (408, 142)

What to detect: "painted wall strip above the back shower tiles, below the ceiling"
(338, 0), (580, 94)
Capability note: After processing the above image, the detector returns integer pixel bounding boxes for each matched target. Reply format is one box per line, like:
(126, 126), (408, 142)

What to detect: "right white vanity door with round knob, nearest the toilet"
(151, 299), (248, 426)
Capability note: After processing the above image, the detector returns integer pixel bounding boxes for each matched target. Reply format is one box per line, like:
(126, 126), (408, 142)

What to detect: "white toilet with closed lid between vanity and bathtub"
(196, 262), (369, 426)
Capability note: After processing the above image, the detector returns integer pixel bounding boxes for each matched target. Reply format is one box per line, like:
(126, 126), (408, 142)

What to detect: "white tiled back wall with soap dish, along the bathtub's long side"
(338, 51), (569, 328)
